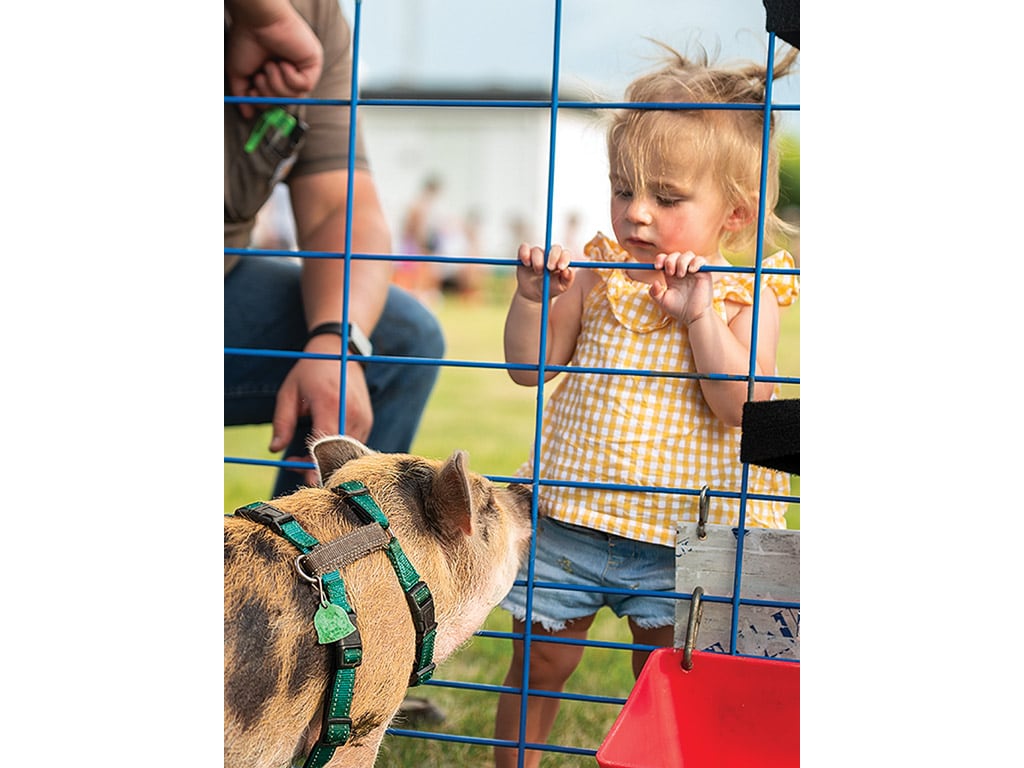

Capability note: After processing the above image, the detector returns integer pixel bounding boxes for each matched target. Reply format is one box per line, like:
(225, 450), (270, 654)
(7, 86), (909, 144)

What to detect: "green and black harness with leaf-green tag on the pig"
(234, 482), (437, 768)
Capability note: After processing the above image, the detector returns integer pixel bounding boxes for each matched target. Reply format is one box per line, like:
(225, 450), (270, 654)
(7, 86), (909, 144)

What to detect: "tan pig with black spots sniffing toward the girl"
(224, 436), (531, 768)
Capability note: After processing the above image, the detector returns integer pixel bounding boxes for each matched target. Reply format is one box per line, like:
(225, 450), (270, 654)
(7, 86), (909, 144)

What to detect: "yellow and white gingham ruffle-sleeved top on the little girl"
(517, 232), (799, 546)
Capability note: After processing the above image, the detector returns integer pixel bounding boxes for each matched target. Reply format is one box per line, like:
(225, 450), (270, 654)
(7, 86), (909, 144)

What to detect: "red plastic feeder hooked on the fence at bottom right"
(597, 648), (800, 768)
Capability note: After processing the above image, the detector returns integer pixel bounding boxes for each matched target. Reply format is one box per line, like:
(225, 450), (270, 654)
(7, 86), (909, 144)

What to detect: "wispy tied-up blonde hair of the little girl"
(607, 41), (799, 252)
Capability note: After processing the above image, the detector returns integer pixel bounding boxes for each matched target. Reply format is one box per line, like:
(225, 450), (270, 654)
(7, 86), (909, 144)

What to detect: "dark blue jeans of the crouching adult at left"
(224, 256), (444, 497)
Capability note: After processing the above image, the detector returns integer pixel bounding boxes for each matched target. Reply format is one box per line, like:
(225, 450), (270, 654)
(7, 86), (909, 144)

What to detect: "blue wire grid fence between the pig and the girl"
(224, 0), (800, 766)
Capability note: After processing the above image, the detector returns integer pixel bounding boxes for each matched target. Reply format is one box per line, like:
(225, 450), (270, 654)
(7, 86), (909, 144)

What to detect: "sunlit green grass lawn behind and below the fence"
(224, 268), (800, 768)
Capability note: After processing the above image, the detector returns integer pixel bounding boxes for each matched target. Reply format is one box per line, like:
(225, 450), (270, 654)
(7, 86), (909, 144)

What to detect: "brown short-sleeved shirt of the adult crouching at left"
(224, 0), (369, 274)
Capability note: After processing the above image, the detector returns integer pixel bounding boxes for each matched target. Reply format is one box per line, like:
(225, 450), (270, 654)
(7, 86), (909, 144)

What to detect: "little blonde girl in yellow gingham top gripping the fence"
(495, 48), (798, 768)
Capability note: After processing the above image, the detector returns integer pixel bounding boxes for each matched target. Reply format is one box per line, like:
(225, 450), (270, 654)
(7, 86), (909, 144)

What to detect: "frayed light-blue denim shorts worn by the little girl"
(502, 517), (676, 632)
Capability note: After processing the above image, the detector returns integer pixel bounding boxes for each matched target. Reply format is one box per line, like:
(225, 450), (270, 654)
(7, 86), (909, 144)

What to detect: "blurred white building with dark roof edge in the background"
(360, 90), (610, 259)
